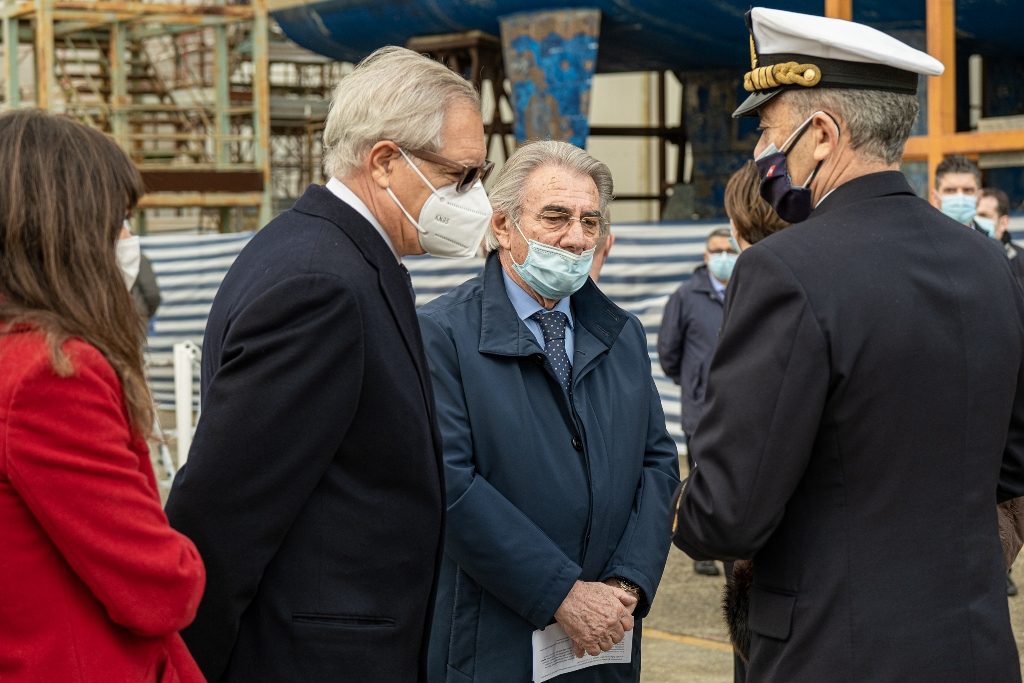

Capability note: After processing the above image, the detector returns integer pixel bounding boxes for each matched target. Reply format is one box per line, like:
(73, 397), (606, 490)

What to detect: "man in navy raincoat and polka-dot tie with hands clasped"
(420, 141), (679, 683)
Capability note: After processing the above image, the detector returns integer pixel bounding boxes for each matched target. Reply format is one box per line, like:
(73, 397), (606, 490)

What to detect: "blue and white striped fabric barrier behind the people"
(142, 217), (1024, 450)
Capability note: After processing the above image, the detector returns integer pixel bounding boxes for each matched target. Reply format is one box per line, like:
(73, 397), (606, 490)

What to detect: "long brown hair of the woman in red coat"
(0, 110), (153, 435)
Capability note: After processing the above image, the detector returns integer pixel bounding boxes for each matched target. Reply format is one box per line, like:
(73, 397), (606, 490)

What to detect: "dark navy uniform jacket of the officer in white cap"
(675, 172), (1024, 683)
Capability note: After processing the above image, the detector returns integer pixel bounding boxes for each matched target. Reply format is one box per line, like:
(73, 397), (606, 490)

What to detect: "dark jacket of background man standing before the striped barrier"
(657, 265), (723, 435)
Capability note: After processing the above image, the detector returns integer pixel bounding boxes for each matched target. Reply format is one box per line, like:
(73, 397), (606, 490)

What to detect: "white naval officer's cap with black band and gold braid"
(732, 7), (943, 118)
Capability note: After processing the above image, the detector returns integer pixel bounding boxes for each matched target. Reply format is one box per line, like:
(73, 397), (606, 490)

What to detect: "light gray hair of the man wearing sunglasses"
(324, 45), (480, 178)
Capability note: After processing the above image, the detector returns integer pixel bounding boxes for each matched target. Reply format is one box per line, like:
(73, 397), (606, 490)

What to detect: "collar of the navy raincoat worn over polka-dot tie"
(478, 252), (628, 360)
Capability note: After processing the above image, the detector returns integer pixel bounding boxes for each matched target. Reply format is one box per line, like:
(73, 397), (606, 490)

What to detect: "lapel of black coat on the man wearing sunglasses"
(295, 185), (434, 423)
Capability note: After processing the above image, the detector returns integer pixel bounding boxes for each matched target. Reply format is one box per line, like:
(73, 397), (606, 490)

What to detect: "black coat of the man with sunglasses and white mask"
(167, 185), (444, 683)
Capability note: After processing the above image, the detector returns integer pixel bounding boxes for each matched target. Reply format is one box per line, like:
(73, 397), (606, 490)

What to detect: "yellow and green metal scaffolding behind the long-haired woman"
(0, 0), (272, 229)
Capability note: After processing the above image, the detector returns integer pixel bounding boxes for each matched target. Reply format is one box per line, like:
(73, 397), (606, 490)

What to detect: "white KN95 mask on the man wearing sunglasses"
(385, 147), (494, 258)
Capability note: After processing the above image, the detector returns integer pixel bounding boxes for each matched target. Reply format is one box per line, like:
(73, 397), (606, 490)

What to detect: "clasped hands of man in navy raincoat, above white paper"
(555, 581), (637, 657)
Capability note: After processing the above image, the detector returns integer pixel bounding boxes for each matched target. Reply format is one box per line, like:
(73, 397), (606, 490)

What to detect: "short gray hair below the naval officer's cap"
(779, 88), (921, 164)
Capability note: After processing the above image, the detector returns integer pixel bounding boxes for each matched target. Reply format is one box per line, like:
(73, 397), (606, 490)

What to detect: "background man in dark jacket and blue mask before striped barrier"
(657, 227), (739, 577)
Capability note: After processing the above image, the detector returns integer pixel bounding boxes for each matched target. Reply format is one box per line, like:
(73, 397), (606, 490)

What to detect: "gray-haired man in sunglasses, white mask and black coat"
(167, 47), (492, 683)
